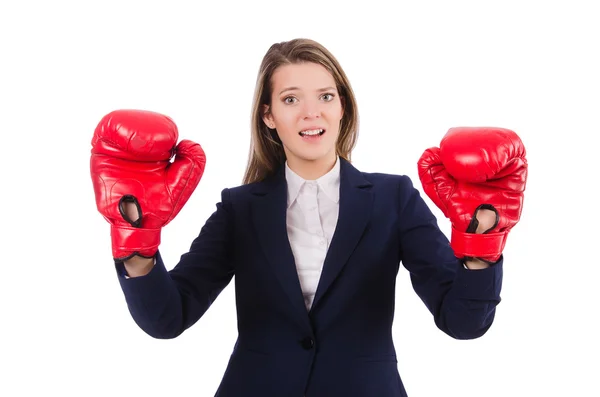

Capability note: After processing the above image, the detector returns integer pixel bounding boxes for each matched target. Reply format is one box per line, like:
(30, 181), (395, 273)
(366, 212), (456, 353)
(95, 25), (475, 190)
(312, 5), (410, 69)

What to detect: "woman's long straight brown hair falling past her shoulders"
(243, 39), (358, 184)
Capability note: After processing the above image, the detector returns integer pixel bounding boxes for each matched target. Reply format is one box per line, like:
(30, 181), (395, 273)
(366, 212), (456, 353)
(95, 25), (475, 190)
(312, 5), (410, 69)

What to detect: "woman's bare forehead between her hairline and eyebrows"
(272, 62), (336, 93)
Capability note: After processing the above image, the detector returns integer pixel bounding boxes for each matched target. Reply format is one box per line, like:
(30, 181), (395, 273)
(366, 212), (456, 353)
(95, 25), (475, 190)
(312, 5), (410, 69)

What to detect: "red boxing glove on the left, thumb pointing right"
(90, 110), (206, 261)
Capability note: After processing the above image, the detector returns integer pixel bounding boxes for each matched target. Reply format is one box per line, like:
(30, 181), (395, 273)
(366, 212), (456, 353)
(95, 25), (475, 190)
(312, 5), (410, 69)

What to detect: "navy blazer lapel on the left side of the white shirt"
(252, 167), (310, 327)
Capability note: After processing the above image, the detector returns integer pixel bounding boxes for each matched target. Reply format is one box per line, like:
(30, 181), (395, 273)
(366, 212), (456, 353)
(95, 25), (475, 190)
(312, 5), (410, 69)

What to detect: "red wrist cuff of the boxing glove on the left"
(110, 225), (161, 261)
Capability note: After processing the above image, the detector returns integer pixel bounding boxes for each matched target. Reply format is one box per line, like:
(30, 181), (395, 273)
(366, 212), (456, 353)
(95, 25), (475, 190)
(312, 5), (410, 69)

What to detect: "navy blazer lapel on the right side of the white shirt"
(311, 158), (373, 312)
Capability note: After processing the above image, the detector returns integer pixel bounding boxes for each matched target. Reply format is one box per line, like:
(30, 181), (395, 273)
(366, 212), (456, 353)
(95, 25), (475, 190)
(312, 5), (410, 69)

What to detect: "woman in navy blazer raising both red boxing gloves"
(91, 39), (526, 397)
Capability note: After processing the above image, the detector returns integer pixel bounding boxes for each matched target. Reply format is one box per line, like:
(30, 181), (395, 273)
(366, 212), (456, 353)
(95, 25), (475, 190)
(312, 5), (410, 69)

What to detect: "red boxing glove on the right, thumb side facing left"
(418, 127), (527, 263)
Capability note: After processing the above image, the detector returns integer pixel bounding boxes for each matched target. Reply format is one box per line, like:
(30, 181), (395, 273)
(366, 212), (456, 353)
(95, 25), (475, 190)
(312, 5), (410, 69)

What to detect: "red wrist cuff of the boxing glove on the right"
(450, 227), (508, 262)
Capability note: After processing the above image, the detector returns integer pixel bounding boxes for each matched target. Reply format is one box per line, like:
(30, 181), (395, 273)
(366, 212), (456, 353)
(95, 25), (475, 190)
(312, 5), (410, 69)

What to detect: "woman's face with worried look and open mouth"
(263, 62), (343, 171)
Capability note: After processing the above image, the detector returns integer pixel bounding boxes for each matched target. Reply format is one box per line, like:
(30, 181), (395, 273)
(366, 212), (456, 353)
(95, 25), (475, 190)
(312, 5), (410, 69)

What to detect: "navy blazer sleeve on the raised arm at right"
(399, 176), (504, 339)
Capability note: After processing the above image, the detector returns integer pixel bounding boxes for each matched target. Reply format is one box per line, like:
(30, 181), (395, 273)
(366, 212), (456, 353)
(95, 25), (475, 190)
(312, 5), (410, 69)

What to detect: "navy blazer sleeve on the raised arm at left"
(117, 189), (234, 339)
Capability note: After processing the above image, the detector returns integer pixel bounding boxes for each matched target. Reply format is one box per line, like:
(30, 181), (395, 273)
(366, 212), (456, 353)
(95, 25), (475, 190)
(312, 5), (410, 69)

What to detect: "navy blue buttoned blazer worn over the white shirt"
(118, 159), (503, 397)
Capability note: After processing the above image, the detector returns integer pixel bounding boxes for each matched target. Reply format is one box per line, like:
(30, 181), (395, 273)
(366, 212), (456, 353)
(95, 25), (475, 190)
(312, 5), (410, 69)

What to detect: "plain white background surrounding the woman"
(0, 0), (600, 397)
